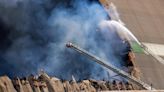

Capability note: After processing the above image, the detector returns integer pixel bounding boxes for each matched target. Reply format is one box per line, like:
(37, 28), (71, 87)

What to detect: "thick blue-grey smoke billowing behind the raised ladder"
(0, 0), (126, 79)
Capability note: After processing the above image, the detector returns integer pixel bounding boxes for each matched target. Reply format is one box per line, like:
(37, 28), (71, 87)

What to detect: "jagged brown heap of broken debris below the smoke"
(0, 73), (141, 92)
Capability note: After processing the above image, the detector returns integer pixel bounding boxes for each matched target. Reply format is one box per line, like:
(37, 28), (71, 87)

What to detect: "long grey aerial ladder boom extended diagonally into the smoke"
(66, 43), (154, 90)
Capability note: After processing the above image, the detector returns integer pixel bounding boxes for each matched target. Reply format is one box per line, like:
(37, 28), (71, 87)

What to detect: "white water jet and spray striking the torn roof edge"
(99, 0), (164, 64)
